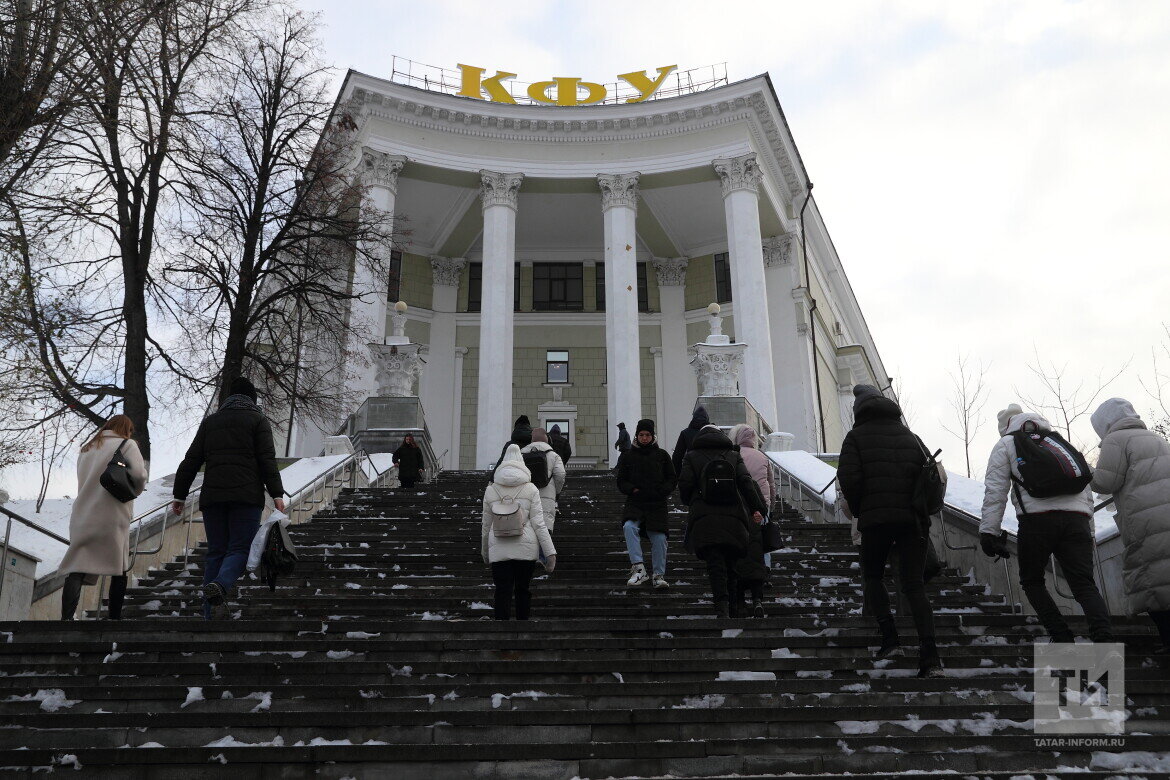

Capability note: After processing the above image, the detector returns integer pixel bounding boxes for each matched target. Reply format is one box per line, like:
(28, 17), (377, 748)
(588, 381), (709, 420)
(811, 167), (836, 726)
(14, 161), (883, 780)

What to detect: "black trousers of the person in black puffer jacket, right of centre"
(861, 523), (935, 642)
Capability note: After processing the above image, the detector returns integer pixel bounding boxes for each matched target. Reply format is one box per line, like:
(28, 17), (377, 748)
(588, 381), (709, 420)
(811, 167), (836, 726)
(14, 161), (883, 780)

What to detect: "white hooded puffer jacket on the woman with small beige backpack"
(480, 444), (557, 564)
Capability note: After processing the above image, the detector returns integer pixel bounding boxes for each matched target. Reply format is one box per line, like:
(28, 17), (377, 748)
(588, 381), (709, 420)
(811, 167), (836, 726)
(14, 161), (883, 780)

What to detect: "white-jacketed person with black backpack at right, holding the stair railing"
(979, 403), (1113, 642)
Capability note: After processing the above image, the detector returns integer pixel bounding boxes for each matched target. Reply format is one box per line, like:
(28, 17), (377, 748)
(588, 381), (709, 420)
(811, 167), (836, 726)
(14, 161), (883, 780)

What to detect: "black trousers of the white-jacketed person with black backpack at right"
(1017, 512), (1113, 642)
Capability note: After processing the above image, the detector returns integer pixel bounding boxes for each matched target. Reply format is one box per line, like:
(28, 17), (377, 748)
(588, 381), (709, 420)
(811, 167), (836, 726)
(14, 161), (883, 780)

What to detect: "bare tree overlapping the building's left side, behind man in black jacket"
(166, 9), (401, 419)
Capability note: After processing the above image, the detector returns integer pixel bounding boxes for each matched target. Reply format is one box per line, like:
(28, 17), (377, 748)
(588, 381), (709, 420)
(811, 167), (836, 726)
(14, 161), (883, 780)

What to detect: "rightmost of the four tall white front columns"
(713, 152), (777, 426)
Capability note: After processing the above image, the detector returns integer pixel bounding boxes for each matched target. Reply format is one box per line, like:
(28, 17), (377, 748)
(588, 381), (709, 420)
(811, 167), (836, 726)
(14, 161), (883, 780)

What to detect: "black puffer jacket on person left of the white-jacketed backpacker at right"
(837, 391), (929, 533)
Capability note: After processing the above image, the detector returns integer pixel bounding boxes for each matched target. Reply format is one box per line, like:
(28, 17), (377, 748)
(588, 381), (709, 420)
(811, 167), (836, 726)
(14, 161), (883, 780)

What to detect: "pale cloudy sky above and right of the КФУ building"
(4, 0), (1170, 493)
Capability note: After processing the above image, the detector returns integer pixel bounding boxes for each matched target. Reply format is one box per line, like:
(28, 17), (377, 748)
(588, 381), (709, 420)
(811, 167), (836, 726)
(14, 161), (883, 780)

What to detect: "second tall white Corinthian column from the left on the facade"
(475, 171), (524, 469)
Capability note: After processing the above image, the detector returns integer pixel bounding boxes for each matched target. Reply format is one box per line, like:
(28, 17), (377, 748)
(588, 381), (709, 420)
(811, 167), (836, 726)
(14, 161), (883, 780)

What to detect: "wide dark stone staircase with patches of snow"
(0, 472), (1170, 780)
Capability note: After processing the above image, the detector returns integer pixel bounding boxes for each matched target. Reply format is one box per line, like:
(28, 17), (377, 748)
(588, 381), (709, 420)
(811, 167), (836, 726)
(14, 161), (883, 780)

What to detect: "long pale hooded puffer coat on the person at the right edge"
(1090, 398), (1170, 614)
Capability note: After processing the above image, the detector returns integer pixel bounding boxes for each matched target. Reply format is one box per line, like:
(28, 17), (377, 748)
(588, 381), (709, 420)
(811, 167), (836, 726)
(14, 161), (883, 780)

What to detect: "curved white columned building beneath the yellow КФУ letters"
(287, 71), (889, 468)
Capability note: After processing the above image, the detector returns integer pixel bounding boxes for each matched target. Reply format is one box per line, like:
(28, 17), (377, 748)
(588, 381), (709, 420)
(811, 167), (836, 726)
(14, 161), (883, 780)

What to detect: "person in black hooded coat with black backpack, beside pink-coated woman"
(679, 426), (768, 617)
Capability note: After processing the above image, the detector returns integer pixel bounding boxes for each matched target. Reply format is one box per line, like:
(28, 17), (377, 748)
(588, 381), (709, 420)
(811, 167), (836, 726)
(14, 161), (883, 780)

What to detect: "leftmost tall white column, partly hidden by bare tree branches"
(350, 146), (406, 396)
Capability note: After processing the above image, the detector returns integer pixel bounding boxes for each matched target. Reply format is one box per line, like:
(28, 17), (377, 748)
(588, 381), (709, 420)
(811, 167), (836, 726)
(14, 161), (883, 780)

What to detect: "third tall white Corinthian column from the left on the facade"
(597, 173), (642, 464)
